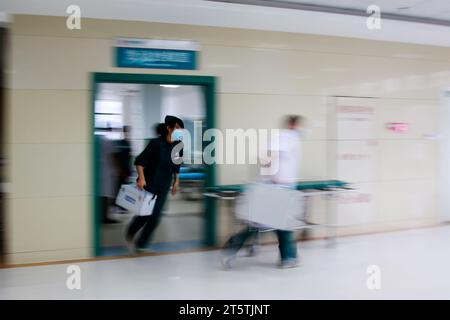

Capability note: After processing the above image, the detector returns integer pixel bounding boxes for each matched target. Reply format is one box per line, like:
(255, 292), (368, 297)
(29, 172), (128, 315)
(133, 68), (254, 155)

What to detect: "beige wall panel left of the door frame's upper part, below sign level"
(10, 90), (91, 144)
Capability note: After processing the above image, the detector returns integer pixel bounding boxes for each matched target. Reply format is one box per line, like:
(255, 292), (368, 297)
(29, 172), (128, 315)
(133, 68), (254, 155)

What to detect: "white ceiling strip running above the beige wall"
(0, 0), (450, 47)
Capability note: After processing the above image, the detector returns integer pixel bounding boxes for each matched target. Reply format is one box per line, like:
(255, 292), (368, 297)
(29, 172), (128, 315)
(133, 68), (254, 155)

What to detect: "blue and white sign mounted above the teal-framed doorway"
(116, 38), (198, 70)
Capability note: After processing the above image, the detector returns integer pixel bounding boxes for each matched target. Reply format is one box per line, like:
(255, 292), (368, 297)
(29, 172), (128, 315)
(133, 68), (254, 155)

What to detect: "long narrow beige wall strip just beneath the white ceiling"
(12, 15), (450, 61)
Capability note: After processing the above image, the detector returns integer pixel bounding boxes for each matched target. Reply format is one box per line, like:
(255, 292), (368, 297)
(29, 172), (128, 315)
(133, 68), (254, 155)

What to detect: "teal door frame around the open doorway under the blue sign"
(91, 72), (216, 256)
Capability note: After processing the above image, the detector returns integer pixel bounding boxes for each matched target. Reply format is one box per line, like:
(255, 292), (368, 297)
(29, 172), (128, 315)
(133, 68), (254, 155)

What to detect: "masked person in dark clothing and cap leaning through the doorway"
(126, 116), (184, 252)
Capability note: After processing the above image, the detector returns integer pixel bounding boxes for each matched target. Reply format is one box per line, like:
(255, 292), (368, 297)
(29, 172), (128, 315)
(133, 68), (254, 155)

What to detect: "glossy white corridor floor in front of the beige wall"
(0, 226), (450, 299)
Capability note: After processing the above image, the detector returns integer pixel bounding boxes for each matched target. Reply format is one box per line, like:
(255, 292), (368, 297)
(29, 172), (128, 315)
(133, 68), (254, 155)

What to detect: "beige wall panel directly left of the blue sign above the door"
(12, 36), (113, 90)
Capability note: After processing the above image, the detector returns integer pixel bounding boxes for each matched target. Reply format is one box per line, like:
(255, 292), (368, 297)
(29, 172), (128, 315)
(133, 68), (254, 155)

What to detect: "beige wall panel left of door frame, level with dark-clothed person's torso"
(11, 144), (91, 198)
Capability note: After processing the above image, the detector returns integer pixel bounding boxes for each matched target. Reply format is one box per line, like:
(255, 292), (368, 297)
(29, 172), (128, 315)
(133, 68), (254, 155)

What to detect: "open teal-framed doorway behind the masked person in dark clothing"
(92, 73), (215, 256)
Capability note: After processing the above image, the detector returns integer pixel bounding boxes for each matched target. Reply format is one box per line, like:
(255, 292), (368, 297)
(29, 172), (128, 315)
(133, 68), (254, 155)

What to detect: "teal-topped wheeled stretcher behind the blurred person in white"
(204, 180), (354, 249)
